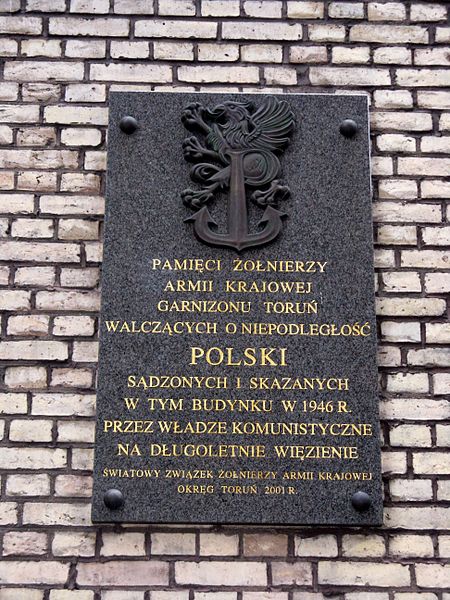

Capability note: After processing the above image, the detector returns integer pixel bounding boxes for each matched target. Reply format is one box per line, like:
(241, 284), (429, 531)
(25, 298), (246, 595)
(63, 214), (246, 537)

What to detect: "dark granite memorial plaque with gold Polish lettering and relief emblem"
(93, 93), (382, 525)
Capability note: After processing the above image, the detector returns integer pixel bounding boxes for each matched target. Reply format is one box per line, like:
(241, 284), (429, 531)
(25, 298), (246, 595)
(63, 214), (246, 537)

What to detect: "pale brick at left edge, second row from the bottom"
(0, 560), (69, 585)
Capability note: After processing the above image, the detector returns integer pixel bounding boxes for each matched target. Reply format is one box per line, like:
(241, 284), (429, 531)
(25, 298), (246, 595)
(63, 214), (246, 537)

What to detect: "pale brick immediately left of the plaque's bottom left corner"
(23, 502), (90, 527)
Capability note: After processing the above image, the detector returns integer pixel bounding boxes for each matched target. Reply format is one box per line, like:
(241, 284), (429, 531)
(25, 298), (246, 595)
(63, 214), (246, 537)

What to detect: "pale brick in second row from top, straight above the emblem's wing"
(222, 22), (303, 41)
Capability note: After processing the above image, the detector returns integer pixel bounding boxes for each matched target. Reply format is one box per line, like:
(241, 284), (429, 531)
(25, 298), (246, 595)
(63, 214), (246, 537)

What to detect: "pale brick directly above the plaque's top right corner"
(309, 67), (391, 86)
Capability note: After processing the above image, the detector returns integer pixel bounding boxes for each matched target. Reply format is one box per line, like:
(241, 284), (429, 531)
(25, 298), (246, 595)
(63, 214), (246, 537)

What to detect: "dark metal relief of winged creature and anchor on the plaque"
(181, 96), (294, 251)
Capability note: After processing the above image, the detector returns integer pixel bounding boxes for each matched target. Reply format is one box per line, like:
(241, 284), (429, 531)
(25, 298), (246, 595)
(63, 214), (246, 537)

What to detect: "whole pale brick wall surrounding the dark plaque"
(0, 0), (450, 600)
